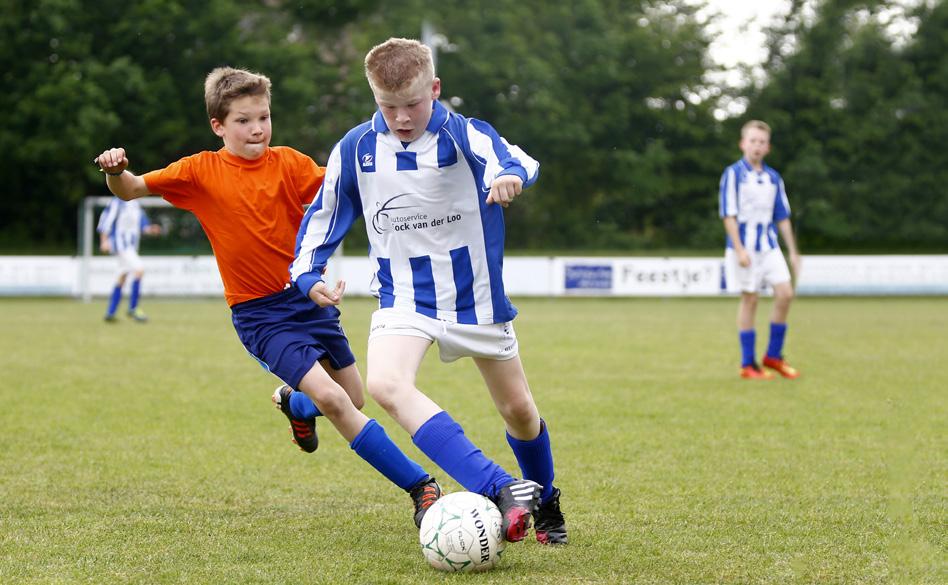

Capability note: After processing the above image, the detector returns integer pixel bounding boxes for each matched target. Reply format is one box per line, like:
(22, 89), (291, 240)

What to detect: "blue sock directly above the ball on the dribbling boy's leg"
(412, 411), (514, 498)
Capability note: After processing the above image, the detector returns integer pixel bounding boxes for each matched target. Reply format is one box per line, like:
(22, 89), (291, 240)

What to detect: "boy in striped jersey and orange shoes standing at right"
(719, 120), (800, 379)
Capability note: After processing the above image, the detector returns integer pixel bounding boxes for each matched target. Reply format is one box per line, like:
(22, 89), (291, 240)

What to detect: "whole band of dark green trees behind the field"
(0, 0), (948, 252)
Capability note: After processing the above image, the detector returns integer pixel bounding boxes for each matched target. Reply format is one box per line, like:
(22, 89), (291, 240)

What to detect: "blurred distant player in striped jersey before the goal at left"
(96, 197), (161, 323)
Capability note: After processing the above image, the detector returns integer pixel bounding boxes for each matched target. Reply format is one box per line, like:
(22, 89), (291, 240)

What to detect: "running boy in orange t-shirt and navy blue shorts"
(95, 67), (441, 525)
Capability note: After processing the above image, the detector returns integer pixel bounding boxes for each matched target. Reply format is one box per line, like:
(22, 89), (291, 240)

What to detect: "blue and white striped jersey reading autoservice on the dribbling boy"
(290, 102), (539, 324)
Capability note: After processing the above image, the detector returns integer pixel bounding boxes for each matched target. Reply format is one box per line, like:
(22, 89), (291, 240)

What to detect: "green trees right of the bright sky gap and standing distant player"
(748, 1), (948, 252)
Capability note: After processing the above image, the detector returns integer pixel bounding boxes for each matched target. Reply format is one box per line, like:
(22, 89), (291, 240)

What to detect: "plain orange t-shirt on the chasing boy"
(143, 146), (326, 306)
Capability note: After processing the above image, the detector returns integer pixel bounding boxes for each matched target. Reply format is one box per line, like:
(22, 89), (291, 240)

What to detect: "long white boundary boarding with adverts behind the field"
(0, 254), (948, 299)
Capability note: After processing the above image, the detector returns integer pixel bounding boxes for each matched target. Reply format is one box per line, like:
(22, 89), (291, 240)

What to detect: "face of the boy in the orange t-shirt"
(211, 95), (273, 160)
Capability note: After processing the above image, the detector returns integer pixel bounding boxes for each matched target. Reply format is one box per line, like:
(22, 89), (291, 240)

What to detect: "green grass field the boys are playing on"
(0, 298), (948, 585)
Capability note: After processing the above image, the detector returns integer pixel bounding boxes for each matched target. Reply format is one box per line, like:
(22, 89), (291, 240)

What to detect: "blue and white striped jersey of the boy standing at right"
(718, 158), (790, 252)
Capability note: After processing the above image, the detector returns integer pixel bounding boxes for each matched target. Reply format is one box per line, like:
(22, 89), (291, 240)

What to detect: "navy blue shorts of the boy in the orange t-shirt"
(230, 286), (355, 389)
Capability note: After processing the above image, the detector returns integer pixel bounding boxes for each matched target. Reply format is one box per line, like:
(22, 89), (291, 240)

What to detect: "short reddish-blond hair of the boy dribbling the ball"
(365, 38), (435, 93)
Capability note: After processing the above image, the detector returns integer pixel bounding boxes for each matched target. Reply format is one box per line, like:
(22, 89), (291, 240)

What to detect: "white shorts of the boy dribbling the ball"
(369, 308), (518, 362)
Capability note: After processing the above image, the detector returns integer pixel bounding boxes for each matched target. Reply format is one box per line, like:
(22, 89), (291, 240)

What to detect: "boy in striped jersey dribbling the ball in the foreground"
(290, 39), (567, 544)
